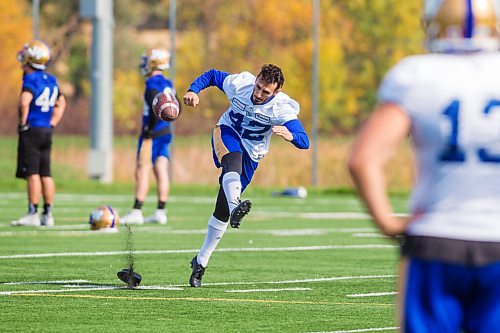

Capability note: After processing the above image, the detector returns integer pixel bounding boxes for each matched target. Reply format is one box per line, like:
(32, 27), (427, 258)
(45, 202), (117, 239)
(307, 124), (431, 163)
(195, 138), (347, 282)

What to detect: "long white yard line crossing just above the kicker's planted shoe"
(0, 244), (397, 259)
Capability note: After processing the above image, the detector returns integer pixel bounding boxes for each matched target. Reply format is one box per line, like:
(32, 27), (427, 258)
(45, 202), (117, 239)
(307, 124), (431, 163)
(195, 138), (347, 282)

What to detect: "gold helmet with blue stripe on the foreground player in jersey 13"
(423, 0), (500, 52)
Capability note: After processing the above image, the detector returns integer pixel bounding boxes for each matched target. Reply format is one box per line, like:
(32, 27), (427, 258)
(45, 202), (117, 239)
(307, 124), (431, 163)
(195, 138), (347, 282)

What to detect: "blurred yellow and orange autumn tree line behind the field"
(0, 0), (423, 135)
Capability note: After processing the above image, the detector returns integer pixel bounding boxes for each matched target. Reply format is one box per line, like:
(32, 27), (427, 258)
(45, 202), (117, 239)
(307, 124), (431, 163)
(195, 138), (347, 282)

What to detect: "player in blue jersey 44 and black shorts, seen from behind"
(11, 40), (66, 226)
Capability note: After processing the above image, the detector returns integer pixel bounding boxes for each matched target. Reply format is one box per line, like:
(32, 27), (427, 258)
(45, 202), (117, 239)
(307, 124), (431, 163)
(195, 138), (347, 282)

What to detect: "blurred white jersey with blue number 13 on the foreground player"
(379, 53), (500, 242)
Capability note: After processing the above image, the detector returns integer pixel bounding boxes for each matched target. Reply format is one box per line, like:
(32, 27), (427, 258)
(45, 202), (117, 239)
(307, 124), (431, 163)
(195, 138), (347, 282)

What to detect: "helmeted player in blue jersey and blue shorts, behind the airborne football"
(120, 48), (179, 224)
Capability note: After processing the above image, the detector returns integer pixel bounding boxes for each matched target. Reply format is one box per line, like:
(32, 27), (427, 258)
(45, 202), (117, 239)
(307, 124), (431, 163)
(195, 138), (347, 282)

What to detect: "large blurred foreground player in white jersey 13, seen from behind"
(349, 0), (500, 332)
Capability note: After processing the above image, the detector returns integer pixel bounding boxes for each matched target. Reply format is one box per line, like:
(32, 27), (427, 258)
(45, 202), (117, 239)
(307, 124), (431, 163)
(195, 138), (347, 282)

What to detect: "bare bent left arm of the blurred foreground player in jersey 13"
(348, 103), (410, 236)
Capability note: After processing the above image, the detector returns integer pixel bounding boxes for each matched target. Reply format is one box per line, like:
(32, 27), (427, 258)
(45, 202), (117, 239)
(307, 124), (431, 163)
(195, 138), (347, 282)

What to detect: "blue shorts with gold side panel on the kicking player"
(212, 125), (259, 193)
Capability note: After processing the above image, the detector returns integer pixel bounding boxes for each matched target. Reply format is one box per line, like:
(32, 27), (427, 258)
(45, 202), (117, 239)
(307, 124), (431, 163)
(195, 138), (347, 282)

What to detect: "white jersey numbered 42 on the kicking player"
(217, 72), (300, 162)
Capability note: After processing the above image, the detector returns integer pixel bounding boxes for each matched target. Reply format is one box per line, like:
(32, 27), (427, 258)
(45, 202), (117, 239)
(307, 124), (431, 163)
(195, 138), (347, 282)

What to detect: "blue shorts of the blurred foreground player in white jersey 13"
(399, 257), (500, 333)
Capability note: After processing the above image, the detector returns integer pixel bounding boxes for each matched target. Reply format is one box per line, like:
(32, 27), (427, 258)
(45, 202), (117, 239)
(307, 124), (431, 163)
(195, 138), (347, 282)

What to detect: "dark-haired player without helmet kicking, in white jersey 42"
(184, 64), (309, 287)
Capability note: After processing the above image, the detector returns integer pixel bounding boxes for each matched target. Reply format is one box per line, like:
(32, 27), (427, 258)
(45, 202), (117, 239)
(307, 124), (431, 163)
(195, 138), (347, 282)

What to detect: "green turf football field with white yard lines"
(0, 188), (405, 332)
